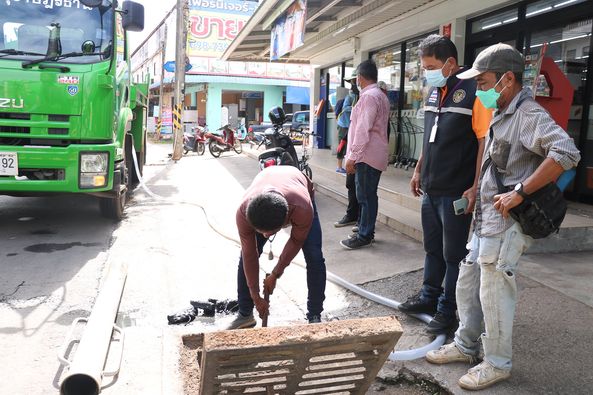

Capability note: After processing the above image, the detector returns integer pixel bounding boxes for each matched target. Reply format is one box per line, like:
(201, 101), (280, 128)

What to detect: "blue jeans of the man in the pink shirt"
(354, 163), (381, 241)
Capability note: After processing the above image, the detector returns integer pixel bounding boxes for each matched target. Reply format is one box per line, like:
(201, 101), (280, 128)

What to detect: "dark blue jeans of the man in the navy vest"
(422, 193), (472, 317)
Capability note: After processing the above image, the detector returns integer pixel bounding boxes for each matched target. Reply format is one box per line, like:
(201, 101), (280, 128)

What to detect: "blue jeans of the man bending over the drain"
(237, 202), (326, 319)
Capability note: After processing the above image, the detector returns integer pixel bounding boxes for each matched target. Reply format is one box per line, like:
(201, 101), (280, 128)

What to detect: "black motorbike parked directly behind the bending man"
(258, 107), (313, 179)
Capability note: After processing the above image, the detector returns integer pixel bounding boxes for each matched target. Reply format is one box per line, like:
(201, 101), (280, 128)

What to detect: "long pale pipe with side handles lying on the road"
(58, 263), (127, 395)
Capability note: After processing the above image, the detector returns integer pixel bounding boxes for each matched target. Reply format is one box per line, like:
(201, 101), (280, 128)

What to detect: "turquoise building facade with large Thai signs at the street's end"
(132, 0), (310, 135)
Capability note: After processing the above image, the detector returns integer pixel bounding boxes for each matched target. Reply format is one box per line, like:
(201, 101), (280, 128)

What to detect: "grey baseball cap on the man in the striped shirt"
(456, 43), (525, 80)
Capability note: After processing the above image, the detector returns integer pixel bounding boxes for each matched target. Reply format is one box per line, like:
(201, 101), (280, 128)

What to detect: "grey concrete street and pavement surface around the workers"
(0, 144), (593, 394)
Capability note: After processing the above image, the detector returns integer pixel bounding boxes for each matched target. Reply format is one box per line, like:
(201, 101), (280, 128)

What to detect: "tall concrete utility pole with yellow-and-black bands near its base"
(173, 0), (188, 161)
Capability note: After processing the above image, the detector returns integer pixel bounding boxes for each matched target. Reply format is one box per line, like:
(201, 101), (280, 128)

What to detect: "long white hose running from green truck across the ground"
(132, 149), (447, 361)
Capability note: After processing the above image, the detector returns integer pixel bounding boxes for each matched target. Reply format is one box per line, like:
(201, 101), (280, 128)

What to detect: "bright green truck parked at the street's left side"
(0, 0), (148, 220)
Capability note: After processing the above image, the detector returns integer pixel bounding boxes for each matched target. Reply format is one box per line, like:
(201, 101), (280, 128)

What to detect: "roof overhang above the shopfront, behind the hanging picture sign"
(222, 0), (433, 63)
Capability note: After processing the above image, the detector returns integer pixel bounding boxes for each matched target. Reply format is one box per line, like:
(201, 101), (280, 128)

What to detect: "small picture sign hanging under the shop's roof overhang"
(270, 0), (307, 60)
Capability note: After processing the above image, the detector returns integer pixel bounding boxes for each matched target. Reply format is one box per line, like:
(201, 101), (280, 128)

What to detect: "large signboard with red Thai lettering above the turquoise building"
(187, 0), (258, 58)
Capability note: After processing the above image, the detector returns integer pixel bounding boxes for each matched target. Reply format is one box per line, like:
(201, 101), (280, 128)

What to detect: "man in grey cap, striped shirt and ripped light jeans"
(426, 44), (580, 390)
